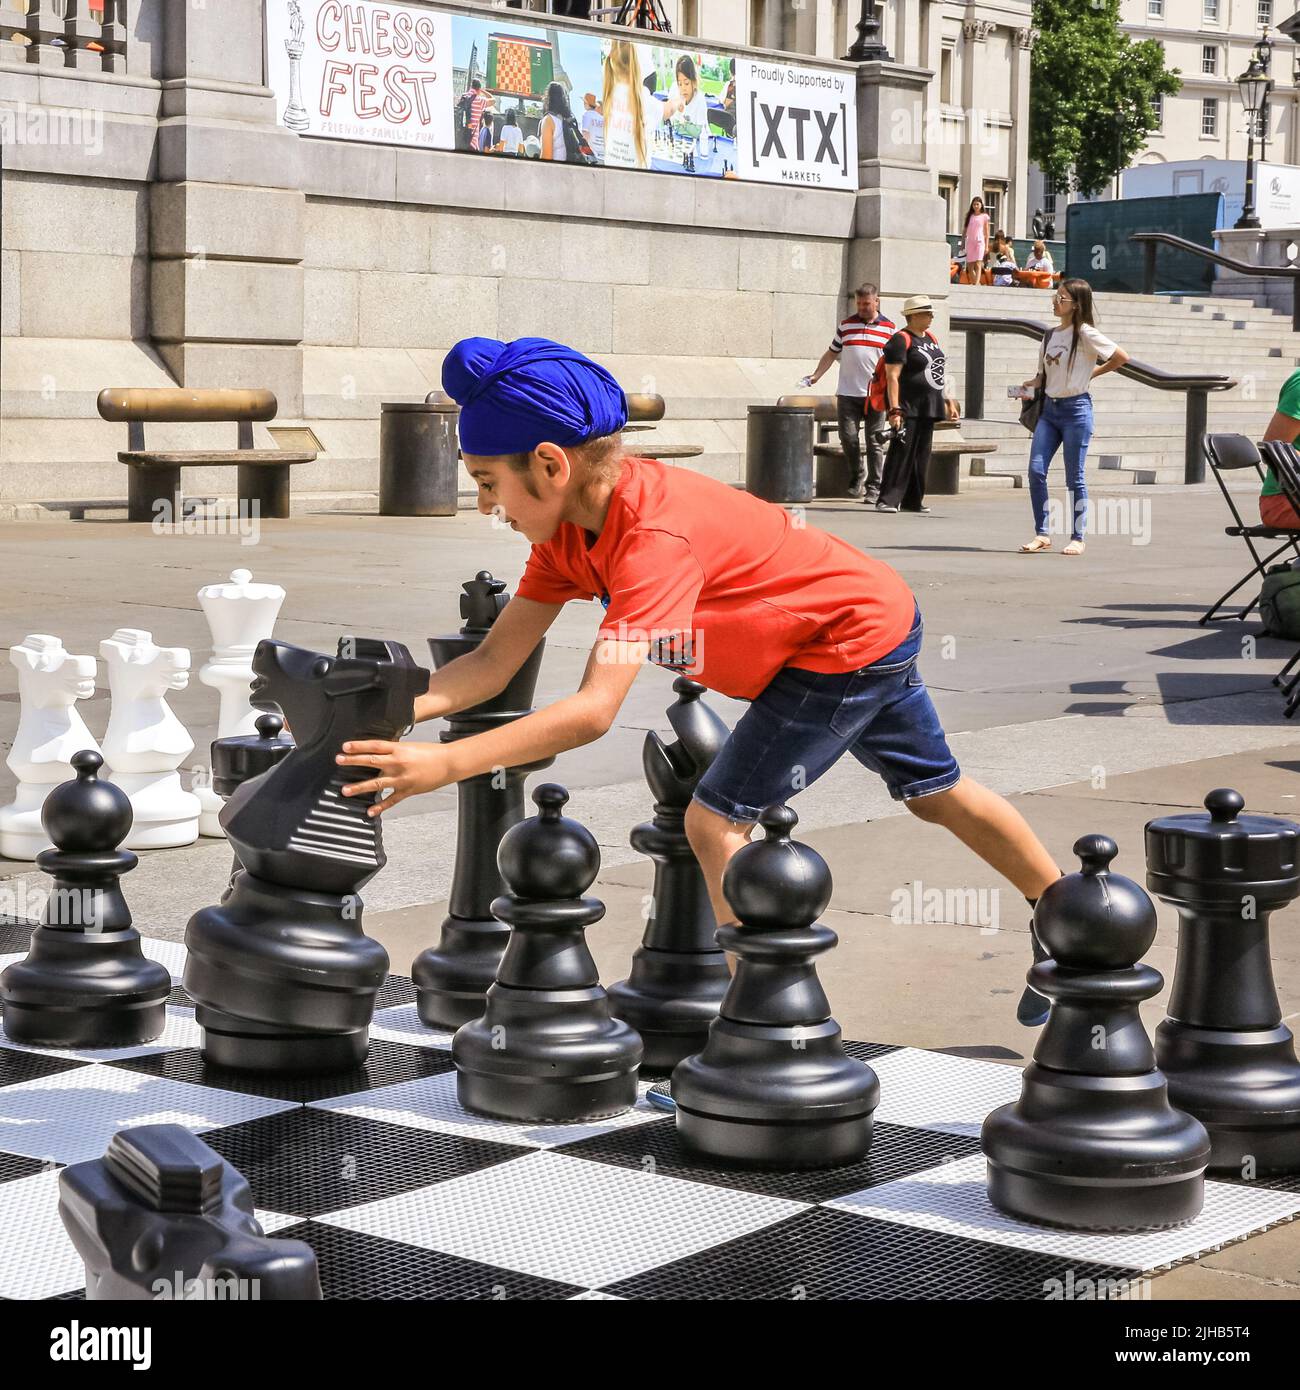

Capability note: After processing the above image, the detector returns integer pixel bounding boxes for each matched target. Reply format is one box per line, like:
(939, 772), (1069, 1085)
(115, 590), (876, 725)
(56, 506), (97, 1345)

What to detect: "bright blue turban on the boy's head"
(442, 338), (627, 456)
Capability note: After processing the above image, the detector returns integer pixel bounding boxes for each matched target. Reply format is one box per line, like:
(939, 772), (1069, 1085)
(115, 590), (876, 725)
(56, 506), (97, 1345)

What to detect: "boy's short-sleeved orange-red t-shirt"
(516, 459), (915, 699)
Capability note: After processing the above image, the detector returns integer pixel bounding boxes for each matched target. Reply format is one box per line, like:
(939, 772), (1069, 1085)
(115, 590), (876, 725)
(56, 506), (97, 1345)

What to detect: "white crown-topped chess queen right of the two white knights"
(195, 570), (285, 838)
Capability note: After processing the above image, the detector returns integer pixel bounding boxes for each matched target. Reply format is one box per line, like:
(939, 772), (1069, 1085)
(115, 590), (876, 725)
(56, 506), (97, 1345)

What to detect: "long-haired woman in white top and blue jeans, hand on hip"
(1021, 279), (1129, 555)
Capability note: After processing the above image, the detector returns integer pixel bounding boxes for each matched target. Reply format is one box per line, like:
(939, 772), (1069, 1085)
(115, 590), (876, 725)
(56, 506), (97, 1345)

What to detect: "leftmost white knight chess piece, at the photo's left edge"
(0, 632), (99, 859)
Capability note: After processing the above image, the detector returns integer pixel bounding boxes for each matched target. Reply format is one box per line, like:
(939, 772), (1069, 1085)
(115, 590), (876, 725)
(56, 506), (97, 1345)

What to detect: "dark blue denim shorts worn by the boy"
(695, 609), (961, 821)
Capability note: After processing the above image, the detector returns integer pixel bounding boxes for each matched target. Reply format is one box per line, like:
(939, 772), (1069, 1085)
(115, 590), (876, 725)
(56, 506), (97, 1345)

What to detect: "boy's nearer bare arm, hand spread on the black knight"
(335, 633), (649, 816)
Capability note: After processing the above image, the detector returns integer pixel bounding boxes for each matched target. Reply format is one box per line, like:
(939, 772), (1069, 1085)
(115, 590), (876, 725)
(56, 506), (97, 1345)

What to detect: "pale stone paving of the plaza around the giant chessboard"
(0, 487), (1300, 1300)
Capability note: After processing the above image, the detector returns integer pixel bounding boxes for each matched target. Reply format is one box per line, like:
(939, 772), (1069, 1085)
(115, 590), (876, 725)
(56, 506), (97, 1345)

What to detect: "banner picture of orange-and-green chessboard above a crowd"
(450, 15), (601, 164)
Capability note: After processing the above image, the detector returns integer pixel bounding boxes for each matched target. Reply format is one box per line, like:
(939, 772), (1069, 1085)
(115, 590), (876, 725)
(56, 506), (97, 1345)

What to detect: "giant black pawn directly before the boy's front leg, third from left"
(673, 805), (880, 1169)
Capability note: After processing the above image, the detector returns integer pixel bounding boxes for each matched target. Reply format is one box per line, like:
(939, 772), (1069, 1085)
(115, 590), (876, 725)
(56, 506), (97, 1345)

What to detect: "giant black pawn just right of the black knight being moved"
(452, 783), (641, 1120)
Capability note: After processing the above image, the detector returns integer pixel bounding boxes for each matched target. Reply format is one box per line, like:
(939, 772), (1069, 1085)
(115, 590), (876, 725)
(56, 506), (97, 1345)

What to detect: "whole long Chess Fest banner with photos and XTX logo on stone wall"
(267, 0), (858, 189)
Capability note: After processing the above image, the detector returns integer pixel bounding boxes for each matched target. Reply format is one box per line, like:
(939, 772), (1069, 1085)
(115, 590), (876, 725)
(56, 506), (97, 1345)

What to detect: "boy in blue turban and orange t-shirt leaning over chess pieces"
(339, 338), (1059, 1024)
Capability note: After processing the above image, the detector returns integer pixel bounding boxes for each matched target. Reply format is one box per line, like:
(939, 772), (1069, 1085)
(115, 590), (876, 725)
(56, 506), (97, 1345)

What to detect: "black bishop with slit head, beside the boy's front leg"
(609, 676), (731, 1072)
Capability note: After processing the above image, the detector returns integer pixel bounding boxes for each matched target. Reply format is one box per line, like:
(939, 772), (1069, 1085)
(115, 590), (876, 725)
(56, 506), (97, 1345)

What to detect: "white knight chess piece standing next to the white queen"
(99, 627), (199, 849)
